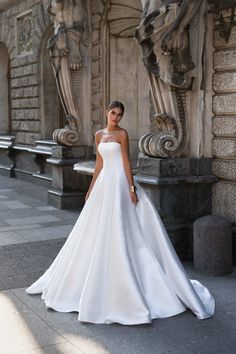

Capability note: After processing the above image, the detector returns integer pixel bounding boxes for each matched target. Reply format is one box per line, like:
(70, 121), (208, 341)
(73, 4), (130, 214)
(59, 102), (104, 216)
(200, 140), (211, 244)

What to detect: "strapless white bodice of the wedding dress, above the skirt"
(98, 141), (123, 170)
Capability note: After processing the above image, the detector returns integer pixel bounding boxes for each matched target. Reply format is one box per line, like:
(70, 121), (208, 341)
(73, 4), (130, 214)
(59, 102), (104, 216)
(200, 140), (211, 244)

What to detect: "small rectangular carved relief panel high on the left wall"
(17, 12), (33, 55)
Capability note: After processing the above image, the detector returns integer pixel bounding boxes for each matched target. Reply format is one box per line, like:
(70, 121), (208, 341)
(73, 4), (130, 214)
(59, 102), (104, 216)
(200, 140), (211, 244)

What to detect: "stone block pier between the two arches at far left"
(0, 0), (51, 145)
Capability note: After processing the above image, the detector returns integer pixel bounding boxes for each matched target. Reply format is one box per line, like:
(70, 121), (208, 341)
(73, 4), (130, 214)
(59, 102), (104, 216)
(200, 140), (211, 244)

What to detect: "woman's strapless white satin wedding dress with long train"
(26, 142), (215, 325)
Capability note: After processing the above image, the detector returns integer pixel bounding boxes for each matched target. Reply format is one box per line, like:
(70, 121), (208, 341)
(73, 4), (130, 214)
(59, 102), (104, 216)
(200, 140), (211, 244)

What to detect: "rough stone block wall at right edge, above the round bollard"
(212, 11), (236, 228)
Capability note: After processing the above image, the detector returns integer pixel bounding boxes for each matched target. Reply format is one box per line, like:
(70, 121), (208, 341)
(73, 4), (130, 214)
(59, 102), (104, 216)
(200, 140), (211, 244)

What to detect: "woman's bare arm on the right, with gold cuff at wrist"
(120, 130), (138, 205)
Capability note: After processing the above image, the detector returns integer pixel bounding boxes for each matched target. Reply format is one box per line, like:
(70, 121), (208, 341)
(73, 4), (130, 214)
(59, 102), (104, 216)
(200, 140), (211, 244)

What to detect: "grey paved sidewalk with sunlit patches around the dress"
(0, 176), (236, 354)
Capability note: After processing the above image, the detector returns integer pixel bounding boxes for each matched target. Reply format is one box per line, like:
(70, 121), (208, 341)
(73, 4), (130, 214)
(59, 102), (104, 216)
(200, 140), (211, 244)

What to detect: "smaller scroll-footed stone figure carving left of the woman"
(48, 0), (86, 146)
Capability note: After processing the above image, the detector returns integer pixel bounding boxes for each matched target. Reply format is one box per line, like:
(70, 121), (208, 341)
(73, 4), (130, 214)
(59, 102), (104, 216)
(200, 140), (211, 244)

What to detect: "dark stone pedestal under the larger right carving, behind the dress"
(135, 154), (217, 259)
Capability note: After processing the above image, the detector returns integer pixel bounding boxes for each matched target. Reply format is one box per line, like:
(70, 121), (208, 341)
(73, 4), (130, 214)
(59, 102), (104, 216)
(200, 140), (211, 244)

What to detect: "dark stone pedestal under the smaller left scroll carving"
(47, 146), (89, 209)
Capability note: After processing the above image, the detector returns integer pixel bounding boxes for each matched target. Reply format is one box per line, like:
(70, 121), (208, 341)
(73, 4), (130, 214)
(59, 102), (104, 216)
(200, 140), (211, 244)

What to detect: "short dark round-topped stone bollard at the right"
(193, 215), (233, 276)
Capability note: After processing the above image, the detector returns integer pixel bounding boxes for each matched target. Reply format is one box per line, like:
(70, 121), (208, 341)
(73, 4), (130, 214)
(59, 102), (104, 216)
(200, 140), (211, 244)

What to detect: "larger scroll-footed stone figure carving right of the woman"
(135, 0), (201, 157)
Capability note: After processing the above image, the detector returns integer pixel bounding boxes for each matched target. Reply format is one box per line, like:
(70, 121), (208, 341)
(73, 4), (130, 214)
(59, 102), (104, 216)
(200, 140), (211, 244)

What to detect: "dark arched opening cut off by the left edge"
(0, 42), (11, 134)
